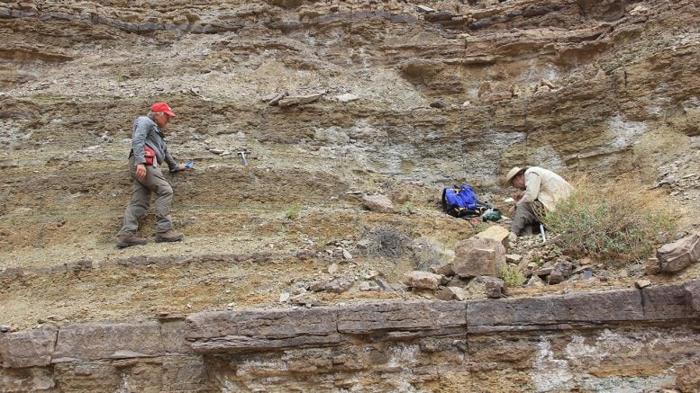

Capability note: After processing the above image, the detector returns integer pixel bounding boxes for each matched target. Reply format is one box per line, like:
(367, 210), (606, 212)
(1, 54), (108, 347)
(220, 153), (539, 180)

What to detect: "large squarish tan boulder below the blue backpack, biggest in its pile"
(453, 237), (506, 277)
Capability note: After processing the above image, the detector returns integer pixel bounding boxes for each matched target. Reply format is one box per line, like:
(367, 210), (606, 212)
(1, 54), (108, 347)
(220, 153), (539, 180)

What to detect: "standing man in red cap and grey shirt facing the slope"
(117, 102), (189, 248)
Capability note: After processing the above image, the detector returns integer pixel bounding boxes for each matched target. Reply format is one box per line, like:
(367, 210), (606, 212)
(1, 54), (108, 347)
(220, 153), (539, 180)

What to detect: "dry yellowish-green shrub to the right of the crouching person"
(543, 178), (679, 263)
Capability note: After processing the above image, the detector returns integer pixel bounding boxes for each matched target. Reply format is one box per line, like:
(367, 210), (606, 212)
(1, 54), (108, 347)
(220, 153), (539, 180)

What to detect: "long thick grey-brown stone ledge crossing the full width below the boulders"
(0, 280), (700, 368)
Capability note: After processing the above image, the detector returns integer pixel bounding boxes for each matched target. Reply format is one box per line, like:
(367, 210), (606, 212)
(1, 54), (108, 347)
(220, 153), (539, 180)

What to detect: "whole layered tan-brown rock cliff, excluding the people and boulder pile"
(0, 0), (700, 393)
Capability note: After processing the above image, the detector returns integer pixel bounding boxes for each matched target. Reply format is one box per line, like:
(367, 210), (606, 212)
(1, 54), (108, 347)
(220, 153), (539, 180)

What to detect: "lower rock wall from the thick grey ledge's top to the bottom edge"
(0, 281), (700, 392)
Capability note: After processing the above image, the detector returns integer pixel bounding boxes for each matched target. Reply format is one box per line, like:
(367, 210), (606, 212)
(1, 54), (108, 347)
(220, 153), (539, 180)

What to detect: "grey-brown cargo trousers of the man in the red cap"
(119, 157), (173, 235)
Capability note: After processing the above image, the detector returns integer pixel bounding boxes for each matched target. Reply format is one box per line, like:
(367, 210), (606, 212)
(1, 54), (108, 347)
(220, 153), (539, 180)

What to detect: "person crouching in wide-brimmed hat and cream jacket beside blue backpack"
(505, 166), (574, 238)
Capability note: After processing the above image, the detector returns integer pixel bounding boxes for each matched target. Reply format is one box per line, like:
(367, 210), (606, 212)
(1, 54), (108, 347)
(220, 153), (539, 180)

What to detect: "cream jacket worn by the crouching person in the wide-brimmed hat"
(520, 166), (574, 212)
